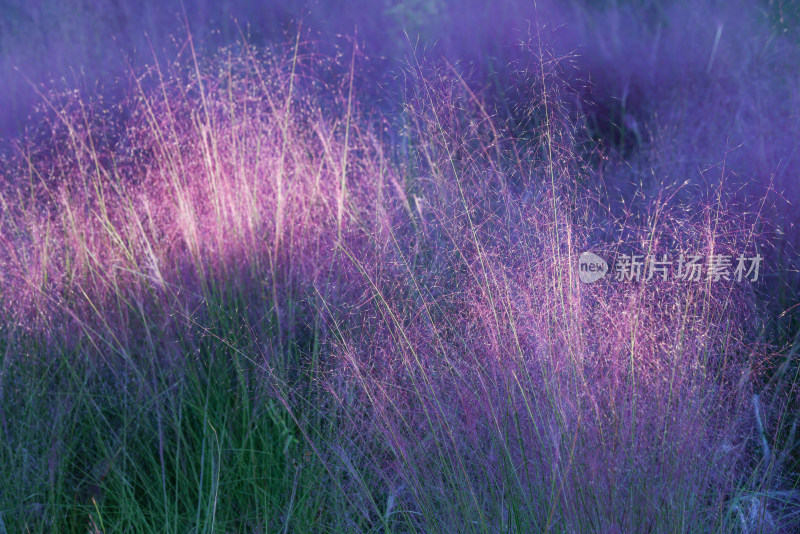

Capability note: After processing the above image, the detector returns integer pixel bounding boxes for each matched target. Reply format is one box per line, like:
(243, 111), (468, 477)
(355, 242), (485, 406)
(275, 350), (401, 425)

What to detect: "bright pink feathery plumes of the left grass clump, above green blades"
(0, 43), (392, 360)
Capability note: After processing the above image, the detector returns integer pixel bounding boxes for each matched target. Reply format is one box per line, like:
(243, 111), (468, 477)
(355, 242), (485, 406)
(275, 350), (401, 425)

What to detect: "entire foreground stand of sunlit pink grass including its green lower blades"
(0, 21), (798, 532)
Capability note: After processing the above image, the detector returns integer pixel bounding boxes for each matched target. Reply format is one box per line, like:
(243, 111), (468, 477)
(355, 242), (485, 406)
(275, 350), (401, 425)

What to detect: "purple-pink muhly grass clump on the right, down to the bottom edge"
(322, 53), (792, 532)
